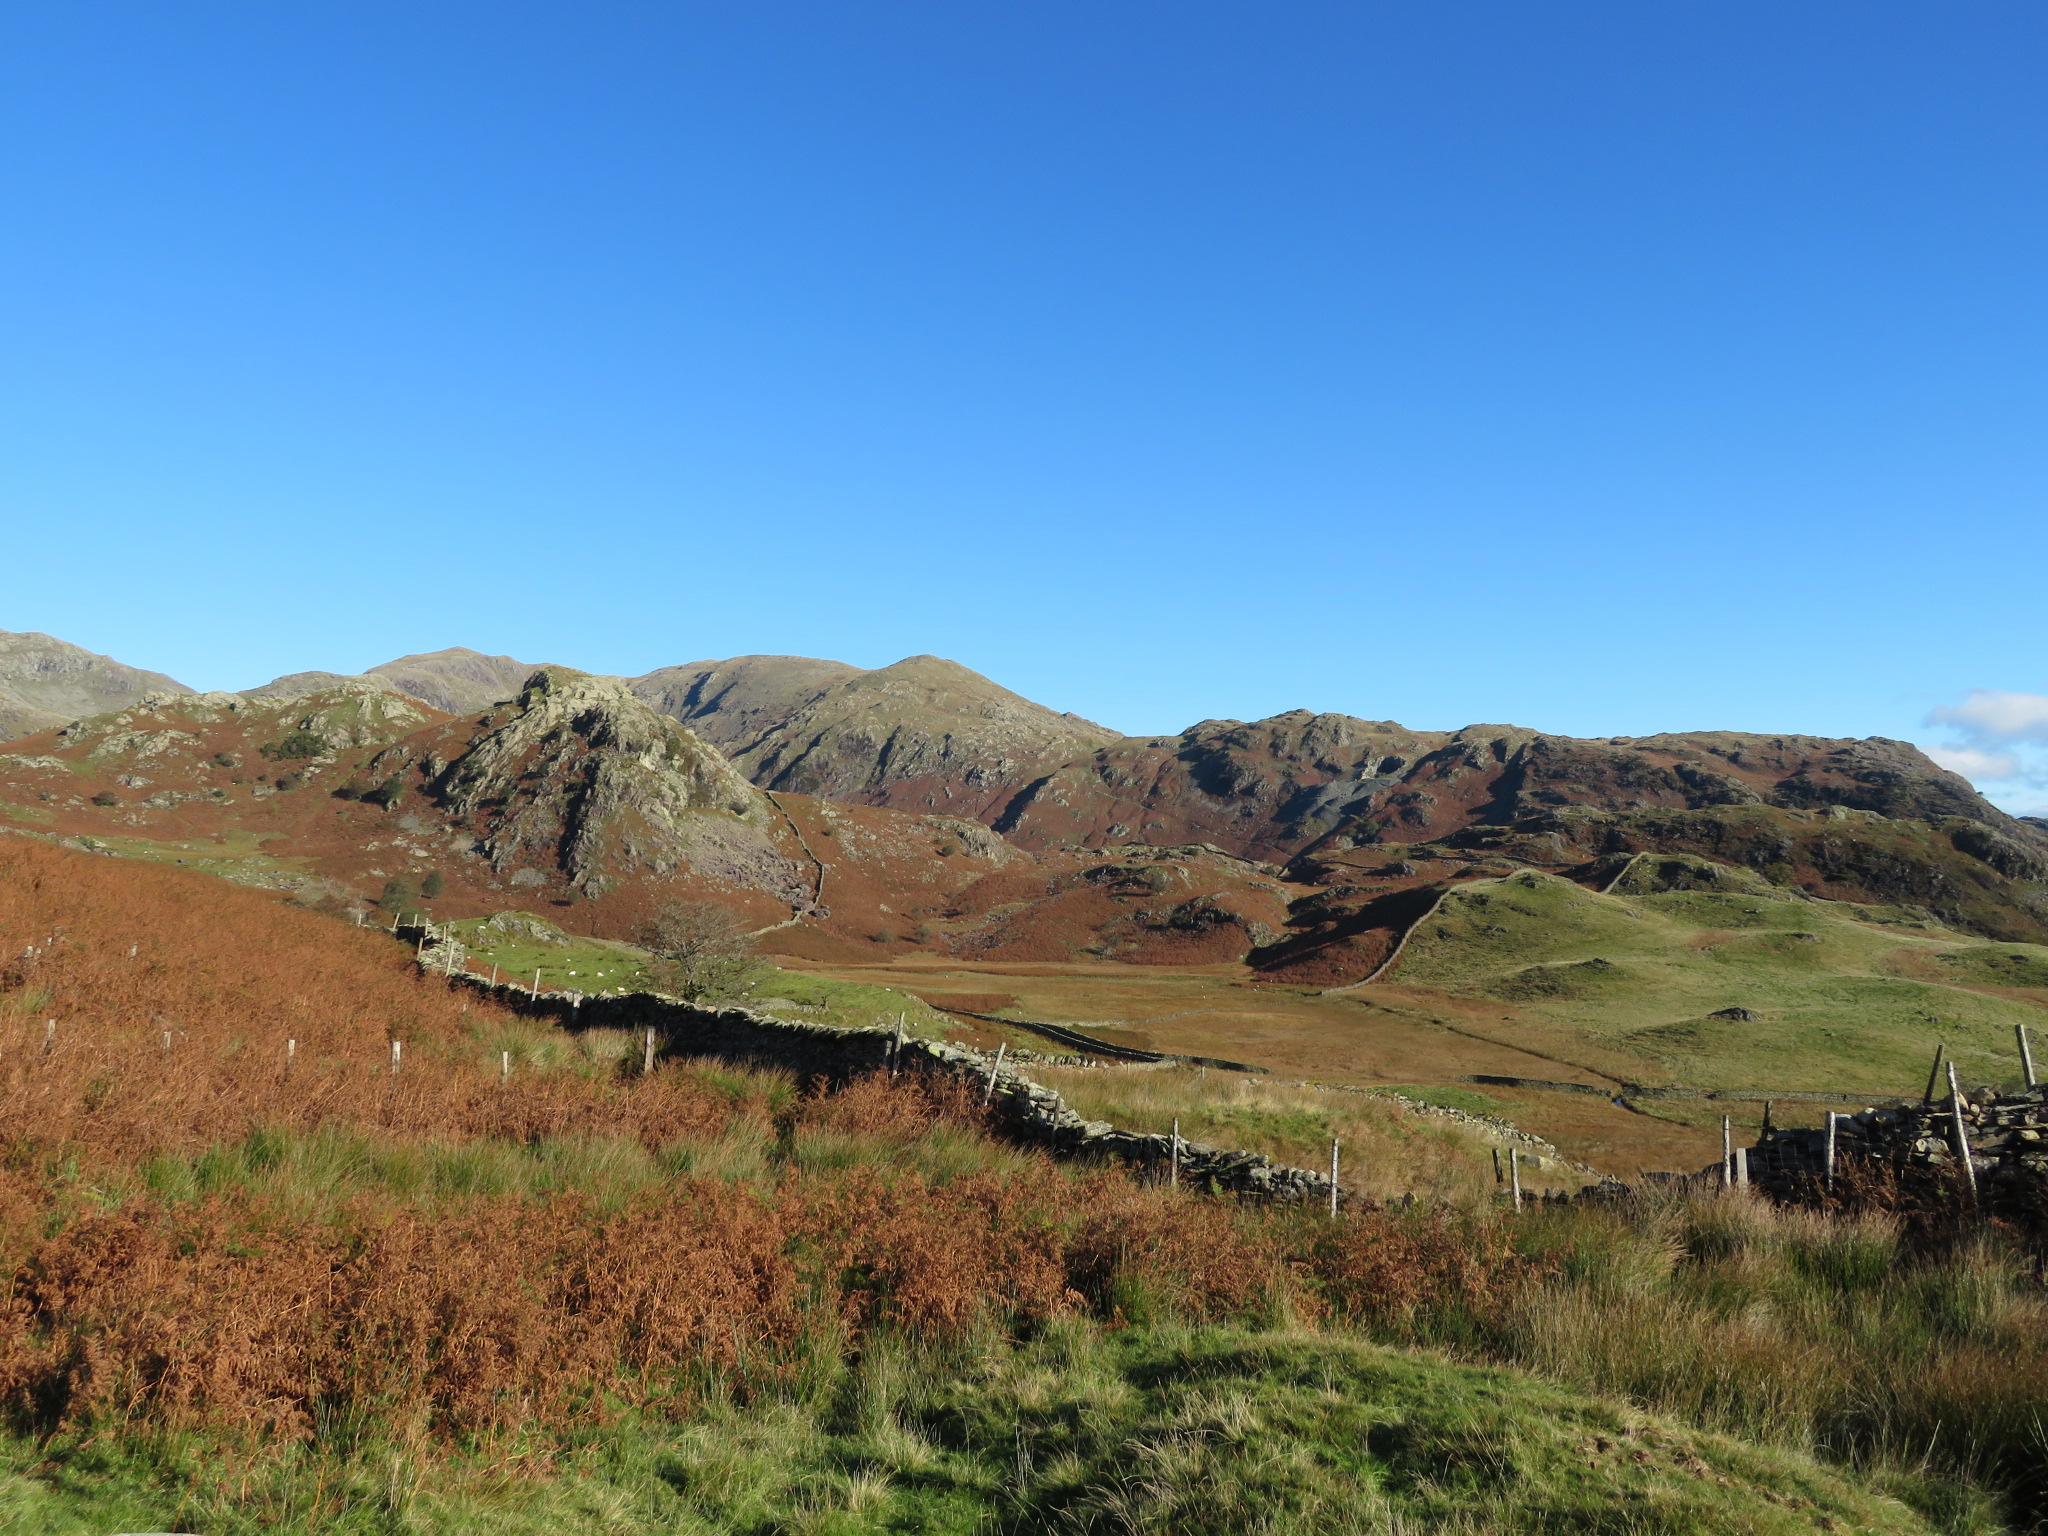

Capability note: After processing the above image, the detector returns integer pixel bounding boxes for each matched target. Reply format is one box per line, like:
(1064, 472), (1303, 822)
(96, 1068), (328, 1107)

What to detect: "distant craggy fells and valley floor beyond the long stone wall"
(0, 635), (2048, 1176)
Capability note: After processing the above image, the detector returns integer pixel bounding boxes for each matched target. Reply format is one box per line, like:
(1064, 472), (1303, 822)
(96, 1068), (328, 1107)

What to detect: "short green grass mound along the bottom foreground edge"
(0, 1323), (1933, 1536)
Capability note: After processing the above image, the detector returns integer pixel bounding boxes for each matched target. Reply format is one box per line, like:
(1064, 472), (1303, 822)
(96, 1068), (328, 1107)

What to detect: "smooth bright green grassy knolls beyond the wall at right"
(1393, 872), (2048, 1094)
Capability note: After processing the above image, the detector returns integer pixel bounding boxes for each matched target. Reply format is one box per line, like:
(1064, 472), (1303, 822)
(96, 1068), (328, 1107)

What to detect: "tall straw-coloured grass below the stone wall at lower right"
(1475, 1194), (2048, 1522)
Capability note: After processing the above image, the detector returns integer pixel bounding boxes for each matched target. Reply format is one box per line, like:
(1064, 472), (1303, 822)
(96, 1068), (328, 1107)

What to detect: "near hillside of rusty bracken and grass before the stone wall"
(0, 840), (2048, 1536)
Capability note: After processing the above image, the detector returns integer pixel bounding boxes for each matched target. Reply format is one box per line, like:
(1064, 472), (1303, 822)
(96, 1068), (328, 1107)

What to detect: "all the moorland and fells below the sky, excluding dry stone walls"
(0, 635), (2048, 1536)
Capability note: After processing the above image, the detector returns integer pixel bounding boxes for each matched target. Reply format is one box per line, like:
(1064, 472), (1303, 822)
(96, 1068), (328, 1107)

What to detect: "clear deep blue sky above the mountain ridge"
(0, 0), (2048, 809)
